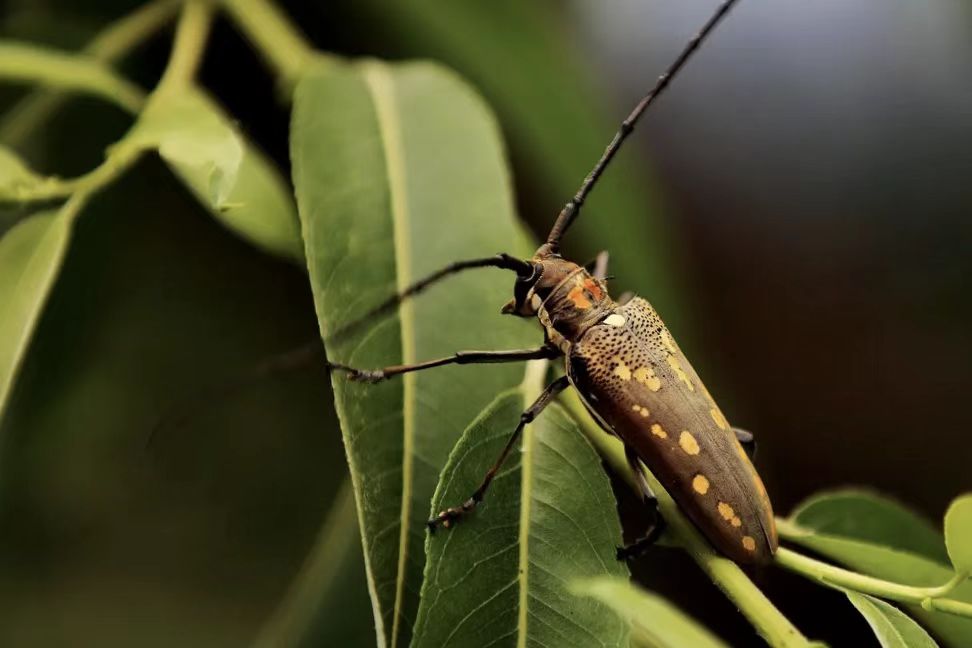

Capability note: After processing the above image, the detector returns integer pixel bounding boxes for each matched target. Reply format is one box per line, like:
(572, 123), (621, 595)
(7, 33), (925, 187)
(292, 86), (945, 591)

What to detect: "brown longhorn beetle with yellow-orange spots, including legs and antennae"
(328, 0), (777, 563)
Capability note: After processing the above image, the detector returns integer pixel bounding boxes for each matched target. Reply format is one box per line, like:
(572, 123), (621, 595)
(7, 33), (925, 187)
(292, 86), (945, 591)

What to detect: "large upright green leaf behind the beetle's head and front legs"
(291, 62), (541, 646)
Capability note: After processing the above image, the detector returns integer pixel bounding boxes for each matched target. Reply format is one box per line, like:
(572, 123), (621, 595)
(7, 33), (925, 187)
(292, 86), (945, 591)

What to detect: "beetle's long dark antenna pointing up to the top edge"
(544, 0), (738, 253)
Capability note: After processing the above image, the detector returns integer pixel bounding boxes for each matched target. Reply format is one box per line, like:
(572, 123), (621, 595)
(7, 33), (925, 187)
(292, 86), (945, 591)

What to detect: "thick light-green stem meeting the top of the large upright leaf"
(221, 0), (314, 91)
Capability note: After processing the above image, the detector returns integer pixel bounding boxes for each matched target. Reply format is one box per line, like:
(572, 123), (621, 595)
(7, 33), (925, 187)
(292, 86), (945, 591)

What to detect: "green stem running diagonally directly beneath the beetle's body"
(561, 393), (812, 647)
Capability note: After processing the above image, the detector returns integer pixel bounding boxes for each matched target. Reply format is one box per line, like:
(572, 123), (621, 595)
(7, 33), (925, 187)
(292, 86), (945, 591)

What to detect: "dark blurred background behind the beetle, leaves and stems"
(0, 0), (972, 646)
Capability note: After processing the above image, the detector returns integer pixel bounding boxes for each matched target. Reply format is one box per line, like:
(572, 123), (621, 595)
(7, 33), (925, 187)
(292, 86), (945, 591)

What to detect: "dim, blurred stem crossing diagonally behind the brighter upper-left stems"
(0, 0), (179, 147)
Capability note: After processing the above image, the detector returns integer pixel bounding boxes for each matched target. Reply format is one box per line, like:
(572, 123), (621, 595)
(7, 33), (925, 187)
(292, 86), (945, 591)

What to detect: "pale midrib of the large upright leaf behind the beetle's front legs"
(362, 64), (415, 648)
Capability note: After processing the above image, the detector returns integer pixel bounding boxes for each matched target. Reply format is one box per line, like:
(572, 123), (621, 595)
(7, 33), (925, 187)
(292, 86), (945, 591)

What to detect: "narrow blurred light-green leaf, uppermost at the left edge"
(0, 41), (142, 113)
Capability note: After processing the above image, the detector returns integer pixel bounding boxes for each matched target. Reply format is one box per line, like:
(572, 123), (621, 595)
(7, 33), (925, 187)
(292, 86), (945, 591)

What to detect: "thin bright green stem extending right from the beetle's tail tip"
(776, 547), (972, 617)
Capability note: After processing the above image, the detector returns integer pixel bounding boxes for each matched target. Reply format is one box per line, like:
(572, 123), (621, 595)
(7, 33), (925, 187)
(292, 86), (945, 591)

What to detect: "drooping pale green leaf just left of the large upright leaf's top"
(119, 89), (303, 260)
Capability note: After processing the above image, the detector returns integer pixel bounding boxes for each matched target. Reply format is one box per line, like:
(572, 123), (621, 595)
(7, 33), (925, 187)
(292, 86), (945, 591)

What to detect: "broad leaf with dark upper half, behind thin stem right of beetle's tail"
(787, 491), (972, 646)
